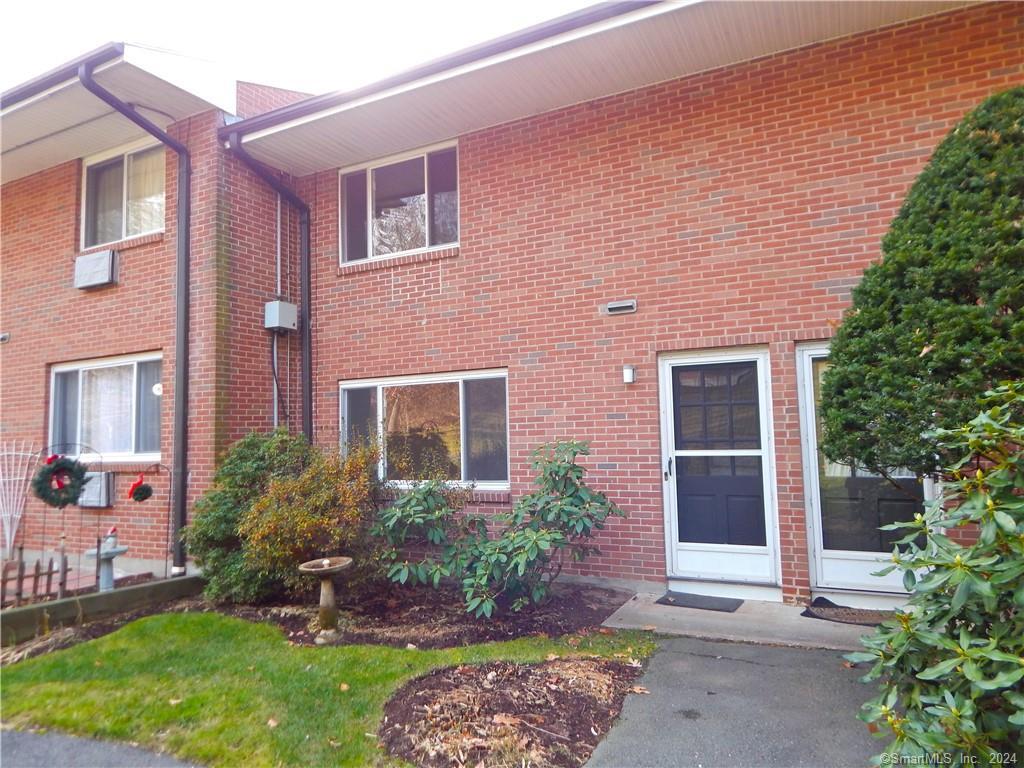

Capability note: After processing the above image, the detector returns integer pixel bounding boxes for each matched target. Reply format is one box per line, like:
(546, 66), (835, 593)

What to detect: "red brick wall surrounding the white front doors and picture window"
(302, 3), (1024, 599)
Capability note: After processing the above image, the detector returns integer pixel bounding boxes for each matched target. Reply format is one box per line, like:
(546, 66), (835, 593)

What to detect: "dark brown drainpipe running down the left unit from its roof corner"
(78, 61), (191, 575)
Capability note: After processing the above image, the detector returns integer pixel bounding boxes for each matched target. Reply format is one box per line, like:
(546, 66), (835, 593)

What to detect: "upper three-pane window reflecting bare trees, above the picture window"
(340, 146), (459, 261)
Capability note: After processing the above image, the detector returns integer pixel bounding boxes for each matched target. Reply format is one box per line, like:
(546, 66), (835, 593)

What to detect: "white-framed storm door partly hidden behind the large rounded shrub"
(798, 345), (926, 593)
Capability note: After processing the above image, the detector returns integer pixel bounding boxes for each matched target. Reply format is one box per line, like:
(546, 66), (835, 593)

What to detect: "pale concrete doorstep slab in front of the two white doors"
(604, 592), (871, 650)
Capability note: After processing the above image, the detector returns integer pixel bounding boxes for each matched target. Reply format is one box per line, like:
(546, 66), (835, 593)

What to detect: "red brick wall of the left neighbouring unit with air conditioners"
(0, 113), (243, 559)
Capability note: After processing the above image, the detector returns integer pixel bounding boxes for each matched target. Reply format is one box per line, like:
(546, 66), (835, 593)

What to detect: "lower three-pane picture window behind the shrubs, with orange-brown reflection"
(341, 372), (508, 483)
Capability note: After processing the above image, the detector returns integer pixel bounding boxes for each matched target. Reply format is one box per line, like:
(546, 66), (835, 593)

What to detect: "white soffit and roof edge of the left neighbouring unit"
(0, 45), (236, 183)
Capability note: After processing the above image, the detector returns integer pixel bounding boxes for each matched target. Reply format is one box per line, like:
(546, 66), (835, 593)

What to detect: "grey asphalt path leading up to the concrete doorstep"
(588, 638), (885, 768)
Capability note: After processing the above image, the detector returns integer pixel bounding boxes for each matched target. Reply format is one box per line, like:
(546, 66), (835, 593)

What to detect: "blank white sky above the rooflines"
(0, 0), (594, 93)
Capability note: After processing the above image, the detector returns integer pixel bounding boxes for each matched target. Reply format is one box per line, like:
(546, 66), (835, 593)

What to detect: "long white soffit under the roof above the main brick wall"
(237, 0), (971, 176)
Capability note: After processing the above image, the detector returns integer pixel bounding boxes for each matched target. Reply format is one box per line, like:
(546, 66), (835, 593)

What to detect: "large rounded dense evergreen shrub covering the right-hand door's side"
(822, 87), (1024, 475)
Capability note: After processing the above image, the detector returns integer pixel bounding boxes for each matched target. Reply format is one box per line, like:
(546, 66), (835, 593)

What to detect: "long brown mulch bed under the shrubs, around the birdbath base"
(0, 585), (631, 666)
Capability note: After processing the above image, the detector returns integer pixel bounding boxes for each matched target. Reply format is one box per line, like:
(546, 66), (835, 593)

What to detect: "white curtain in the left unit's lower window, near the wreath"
(81, 365), (134, 454)
